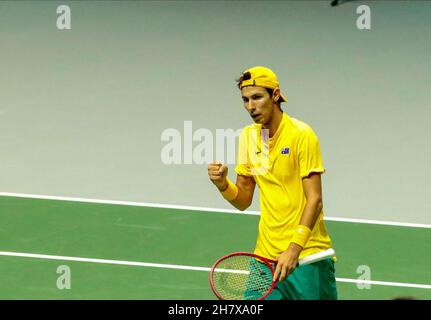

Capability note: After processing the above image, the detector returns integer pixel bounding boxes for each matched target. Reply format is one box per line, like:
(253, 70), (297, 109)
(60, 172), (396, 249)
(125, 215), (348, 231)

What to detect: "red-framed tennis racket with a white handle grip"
(210, 248), (335, 300)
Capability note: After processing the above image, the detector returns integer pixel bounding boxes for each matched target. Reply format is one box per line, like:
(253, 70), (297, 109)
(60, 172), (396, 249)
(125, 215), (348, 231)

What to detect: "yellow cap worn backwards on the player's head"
(238, 66), (287, 102)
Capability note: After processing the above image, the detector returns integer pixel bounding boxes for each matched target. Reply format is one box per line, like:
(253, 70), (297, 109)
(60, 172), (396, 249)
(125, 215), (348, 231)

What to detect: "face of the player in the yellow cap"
(241, 86), (274, 125)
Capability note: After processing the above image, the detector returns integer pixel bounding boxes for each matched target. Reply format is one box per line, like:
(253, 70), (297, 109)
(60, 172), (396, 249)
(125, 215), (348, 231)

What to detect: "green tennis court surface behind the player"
(0, 192), (431, 300)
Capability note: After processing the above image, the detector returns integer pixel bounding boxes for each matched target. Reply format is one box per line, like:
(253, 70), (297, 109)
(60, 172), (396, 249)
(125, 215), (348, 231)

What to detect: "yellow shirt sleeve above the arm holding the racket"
(298, 128), (325, 178)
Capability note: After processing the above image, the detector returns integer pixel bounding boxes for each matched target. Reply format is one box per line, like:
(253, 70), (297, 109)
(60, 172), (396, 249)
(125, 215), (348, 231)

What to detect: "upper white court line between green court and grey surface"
(0, 192), (431, 229)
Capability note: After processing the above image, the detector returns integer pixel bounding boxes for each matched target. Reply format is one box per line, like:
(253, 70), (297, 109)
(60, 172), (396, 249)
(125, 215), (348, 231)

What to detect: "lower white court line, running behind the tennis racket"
(0, 251), (431, 289)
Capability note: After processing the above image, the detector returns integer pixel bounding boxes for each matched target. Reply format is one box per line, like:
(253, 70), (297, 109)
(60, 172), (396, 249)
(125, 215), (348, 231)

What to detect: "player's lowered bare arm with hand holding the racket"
(274, 173), (323, 281)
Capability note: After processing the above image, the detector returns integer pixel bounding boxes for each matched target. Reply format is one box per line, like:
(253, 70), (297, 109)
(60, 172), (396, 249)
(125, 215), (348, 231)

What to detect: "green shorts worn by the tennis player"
(265, 258), (338, 300)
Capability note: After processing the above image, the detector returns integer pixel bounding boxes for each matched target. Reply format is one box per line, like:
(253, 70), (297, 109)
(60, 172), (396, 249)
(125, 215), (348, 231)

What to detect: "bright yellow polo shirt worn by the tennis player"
(235, 113), (332, 259)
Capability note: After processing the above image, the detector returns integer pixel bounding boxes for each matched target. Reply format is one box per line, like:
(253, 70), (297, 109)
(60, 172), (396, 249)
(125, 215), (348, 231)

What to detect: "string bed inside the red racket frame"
(213, 256), (272, 300)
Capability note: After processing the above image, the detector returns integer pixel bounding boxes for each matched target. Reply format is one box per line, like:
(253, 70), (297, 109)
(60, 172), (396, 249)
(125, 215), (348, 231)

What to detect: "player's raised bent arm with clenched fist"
(208, 162), (256, 211)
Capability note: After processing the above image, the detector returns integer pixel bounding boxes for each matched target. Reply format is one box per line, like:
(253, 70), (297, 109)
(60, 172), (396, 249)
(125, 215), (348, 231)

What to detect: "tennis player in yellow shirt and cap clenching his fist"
(208, 66), (337, 300)
